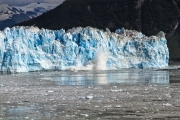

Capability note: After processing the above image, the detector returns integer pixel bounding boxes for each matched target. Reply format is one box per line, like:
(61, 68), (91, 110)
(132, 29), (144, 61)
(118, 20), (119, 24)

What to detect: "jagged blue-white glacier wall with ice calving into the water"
(0, 27), (169, 72)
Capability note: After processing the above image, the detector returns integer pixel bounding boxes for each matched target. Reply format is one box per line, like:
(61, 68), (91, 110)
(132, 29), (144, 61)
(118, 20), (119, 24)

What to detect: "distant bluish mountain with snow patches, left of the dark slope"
(0, 3), (57, 30)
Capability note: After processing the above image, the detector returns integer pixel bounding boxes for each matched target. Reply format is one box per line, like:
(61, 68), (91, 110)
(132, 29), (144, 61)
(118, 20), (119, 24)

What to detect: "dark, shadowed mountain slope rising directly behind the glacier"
(15, 0), (180, 59)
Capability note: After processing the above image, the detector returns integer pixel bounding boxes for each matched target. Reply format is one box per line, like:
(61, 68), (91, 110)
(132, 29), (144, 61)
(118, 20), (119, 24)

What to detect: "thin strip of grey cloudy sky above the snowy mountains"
(0, 0), (64, 6)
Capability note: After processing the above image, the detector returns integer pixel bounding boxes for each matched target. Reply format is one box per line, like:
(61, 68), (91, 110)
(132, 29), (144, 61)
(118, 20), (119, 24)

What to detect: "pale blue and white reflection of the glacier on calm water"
(39, 69), (169, 85)
